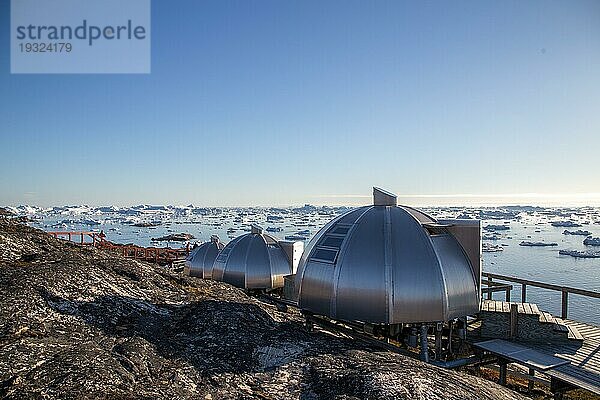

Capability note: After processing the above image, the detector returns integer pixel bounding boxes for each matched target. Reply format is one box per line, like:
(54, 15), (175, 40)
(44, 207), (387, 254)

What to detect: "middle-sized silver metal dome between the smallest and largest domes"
(212, 225), (292, 289)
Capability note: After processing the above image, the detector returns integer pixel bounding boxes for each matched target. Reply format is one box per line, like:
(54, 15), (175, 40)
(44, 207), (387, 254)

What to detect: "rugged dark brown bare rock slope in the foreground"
(0, 217), (521, 400)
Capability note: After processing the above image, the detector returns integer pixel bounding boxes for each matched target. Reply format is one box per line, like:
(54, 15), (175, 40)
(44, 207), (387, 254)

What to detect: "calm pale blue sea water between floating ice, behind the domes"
(32, 209), (600, 325)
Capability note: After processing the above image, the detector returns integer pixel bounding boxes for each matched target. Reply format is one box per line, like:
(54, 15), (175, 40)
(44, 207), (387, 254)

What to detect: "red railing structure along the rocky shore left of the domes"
(47, 231), (190, 264)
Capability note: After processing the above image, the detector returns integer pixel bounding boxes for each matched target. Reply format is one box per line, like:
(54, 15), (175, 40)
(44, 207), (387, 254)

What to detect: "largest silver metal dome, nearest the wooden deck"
(296, 188), (479, 324)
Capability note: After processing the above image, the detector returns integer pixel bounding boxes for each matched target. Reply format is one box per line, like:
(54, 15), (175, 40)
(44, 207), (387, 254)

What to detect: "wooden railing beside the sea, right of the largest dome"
(481, 272), (600, 319)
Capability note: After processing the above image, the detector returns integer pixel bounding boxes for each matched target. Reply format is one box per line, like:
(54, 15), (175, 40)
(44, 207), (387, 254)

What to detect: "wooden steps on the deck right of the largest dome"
(479, 300), (583, 342)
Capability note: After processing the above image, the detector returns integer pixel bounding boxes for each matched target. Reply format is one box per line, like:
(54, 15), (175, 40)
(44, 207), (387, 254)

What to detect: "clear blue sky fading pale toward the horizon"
(0, 0), (600, 205)
